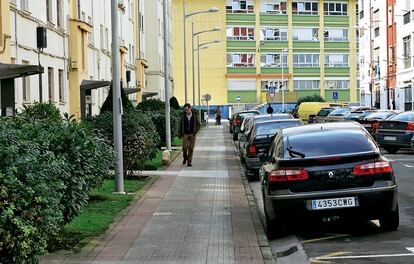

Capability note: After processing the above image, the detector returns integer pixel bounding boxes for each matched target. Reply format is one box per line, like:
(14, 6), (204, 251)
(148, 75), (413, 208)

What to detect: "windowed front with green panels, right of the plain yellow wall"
(226, 0), (359, 103)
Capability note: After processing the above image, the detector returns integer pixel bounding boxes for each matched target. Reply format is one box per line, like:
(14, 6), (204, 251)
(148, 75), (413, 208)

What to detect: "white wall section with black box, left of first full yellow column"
(10, 0), (69, 112)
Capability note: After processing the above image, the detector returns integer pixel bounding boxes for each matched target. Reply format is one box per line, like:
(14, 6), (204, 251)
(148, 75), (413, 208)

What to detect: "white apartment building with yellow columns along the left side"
(0, 0), (154, 118)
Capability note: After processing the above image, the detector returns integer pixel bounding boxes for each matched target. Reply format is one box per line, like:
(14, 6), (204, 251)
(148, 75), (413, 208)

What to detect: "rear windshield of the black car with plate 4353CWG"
(284, 129), (377, 158)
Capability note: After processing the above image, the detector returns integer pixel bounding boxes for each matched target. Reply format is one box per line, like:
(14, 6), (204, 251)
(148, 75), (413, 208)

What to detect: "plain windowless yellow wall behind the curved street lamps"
(172, 0), (227, 105)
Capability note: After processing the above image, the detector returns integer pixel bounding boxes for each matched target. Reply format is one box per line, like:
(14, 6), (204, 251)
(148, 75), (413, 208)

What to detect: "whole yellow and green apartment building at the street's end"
(173, 0), (359, 109)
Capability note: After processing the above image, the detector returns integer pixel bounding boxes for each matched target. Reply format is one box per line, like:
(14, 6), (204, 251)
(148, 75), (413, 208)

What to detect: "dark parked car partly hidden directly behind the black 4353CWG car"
(244, 119), (303, 178)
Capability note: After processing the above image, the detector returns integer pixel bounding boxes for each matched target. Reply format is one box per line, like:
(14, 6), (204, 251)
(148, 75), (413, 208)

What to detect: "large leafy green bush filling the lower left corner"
(0, 104), (113, 264)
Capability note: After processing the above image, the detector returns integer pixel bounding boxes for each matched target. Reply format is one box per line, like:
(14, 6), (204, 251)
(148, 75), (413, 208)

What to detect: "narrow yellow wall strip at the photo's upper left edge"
(0, 0), (11, 63)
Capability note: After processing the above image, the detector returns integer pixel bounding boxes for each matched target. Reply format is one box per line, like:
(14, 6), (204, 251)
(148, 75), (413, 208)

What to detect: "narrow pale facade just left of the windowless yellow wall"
(144, 0), (172, 100)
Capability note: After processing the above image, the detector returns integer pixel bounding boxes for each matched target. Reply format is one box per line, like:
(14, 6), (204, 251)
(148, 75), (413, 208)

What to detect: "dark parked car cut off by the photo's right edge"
(375, 111), (414, 154)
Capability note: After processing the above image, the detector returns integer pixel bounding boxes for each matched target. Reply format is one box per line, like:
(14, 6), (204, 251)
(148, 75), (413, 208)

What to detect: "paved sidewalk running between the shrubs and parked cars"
(41, 124), (269, 264)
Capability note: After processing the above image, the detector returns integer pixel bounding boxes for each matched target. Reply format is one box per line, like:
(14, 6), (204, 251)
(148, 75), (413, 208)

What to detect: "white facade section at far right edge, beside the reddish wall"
(396, 0), (414, 110)
